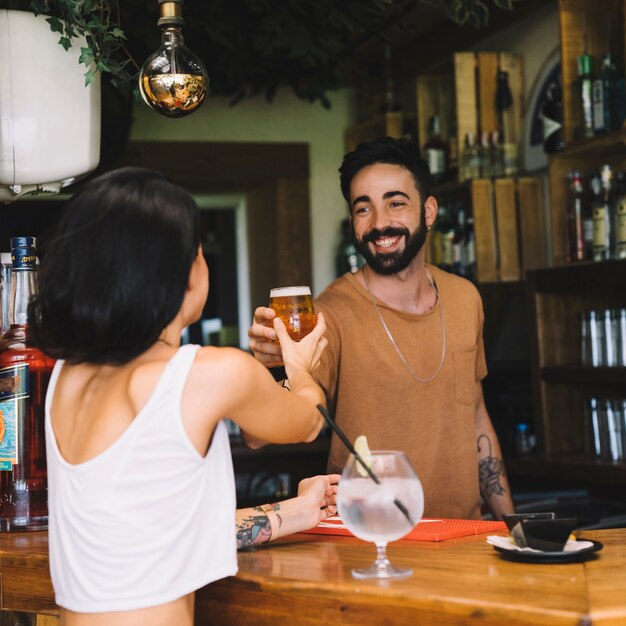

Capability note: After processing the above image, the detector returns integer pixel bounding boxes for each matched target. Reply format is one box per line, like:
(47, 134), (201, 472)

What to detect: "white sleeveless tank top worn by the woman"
(46, 345), (237, 613)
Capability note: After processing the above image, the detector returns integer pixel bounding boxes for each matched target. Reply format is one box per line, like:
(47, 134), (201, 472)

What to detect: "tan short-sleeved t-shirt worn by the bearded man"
(315, 266), (487, 519)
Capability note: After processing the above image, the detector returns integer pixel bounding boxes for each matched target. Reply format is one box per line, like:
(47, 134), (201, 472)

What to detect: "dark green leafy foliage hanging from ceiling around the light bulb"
(18, 0), (516, 107)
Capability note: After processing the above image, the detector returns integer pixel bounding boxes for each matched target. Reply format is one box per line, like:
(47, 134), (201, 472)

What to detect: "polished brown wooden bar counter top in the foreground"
(0, 529), (626, 626)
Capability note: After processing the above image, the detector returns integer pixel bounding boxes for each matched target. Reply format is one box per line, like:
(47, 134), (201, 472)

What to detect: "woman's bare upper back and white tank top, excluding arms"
(46, 345), (237, 624)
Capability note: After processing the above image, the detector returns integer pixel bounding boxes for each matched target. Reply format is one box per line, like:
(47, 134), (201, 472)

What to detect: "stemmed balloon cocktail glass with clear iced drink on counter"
(337, 450), (424, 578)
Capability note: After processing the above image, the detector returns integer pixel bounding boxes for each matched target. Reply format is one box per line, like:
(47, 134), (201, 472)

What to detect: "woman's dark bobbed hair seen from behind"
(29, 167), (200, 364)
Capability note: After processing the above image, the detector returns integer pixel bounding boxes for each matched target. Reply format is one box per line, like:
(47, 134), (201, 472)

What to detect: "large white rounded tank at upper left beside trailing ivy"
(0, 9), (100, 201)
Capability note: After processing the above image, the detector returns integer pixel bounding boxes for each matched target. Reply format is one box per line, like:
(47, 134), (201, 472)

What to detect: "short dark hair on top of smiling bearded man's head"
(339, 137), (430, 204)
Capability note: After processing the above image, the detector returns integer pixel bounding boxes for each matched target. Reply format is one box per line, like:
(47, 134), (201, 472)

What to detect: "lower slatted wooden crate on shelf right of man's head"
(469, 177), (546, 282)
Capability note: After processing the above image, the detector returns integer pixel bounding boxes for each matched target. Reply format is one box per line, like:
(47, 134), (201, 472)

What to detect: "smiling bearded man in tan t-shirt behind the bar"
(249, 137), (513, 519)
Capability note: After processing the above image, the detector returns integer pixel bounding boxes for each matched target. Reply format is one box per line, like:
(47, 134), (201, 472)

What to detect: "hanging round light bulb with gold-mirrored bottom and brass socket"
(139, 0), (209, 117)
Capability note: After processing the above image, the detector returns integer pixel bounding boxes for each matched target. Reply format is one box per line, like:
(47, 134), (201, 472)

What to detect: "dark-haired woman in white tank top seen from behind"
(30, 168), (334, 626)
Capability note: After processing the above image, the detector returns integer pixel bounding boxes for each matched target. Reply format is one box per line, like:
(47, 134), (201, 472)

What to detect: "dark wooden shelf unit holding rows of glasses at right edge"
(527, 261), (626, 483)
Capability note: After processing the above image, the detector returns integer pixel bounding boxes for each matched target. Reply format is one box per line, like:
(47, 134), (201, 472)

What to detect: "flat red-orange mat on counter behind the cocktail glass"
(304, 516), (506, 541)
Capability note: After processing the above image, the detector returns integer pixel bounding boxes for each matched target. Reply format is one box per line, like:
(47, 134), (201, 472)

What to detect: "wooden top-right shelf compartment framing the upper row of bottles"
(559, 0), (626, 147)
